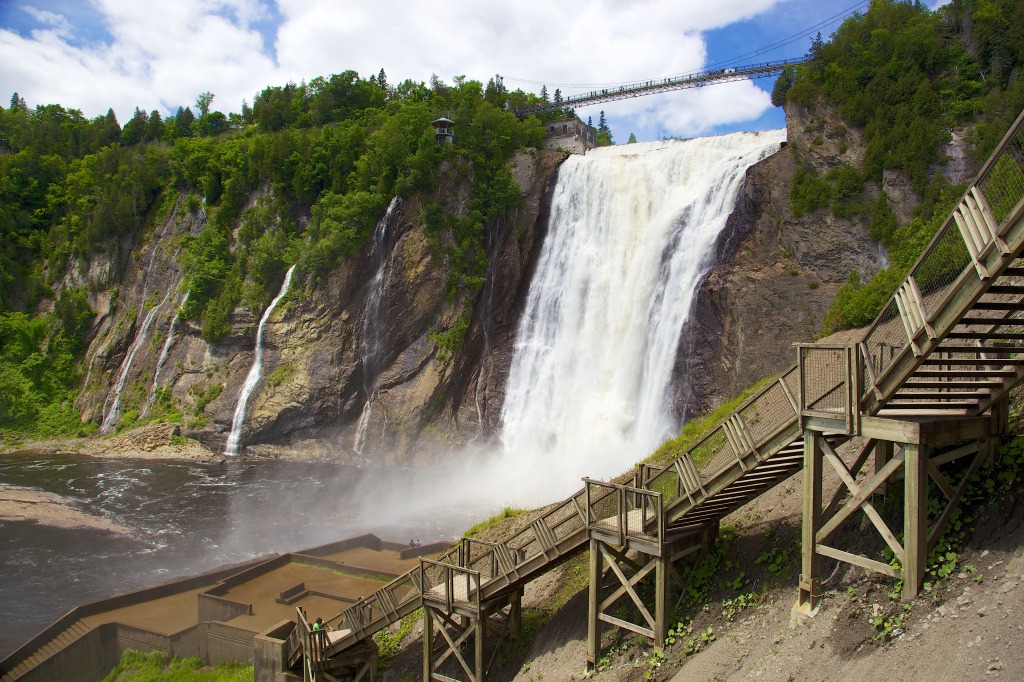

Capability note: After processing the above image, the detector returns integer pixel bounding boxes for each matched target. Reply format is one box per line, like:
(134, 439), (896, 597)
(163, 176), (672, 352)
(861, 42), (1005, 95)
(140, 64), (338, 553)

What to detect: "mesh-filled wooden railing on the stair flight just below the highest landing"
(639, 366), (800, 508)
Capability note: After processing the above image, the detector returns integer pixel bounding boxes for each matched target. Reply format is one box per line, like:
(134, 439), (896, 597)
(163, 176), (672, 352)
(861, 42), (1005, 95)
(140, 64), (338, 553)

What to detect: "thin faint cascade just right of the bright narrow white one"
(352, 197), (401, 455)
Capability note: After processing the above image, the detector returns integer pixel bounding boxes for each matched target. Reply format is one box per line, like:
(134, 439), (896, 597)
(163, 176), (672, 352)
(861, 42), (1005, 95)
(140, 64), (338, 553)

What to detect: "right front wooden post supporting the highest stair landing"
(903, 443), (928, 599)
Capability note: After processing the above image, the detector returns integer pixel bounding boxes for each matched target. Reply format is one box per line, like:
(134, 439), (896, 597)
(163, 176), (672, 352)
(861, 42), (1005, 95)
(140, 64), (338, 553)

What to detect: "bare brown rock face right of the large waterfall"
(675, 97), (977, 418)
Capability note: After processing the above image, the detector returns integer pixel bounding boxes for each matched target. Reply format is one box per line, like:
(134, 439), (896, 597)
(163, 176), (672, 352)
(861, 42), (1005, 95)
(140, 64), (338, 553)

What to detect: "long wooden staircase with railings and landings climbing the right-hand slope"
(299, 107), (1024, 679)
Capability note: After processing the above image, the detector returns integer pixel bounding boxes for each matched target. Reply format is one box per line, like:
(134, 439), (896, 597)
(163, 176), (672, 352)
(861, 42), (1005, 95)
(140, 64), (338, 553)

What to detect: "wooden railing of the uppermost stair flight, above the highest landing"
(861, 107), (1024, 399)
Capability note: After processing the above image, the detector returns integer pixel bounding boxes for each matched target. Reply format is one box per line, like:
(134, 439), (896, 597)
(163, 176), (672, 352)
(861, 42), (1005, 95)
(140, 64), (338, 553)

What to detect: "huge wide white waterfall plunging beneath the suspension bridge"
(501, 130), (785, 484)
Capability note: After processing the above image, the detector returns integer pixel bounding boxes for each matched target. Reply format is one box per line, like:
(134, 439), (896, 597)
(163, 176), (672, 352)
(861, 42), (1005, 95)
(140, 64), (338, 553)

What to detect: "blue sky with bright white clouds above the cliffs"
(0, 0), (945, 142)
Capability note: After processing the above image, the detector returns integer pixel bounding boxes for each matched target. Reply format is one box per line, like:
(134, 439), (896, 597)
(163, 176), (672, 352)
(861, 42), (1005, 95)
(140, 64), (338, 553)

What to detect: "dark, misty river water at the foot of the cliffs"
(0, 453), (477, 657)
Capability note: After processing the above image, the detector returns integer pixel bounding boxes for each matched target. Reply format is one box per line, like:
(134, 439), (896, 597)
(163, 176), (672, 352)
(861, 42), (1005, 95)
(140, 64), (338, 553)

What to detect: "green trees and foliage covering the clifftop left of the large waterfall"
(0, 71), (544, 432)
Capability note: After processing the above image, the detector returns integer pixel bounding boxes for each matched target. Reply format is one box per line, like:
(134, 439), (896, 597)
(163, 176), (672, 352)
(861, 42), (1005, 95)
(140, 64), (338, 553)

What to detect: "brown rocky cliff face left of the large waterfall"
(78, 152), (565, 465)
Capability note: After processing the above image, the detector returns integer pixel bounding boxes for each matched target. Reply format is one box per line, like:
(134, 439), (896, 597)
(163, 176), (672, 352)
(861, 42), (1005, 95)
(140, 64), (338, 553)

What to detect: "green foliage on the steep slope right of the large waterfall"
(772, 0), (1024, 335)
